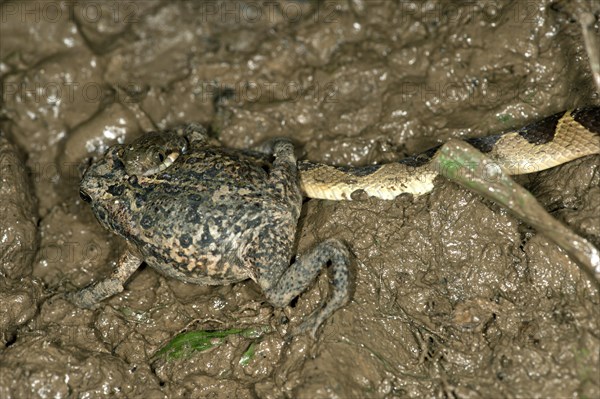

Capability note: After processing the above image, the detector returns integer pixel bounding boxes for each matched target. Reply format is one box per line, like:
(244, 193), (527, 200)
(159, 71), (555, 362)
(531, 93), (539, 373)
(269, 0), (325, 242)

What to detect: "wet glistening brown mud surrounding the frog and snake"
(0, 0), (600, 399)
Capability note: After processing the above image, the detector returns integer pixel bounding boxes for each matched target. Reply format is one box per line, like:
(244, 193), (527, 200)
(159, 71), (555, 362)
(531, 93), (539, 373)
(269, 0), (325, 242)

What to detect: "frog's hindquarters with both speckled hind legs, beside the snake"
(254, 139), (350, 338)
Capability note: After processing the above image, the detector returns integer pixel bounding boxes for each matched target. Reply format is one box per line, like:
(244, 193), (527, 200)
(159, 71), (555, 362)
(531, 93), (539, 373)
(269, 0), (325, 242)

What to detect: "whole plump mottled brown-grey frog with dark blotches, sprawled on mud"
(69, 123), (351, 338)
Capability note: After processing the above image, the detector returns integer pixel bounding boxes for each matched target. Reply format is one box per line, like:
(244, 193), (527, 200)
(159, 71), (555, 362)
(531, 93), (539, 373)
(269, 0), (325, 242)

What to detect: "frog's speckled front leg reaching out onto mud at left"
(67, 249), (142, 308)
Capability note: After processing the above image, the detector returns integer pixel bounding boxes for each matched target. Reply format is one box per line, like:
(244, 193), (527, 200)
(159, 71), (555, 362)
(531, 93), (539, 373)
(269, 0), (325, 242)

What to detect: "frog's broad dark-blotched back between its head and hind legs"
(124, 147), (282, 284)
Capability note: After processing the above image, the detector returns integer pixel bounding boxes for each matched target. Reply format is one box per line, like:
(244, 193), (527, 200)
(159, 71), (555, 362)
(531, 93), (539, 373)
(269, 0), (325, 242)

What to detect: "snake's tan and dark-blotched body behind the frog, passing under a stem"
(298, 106), (600, 200)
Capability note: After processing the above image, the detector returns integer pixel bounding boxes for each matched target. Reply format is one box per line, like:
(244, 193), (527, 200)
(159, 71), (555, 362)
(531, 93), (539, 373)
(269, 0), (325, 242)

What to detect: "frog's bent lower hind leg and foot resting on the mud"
(265, 239), (350, 338)
